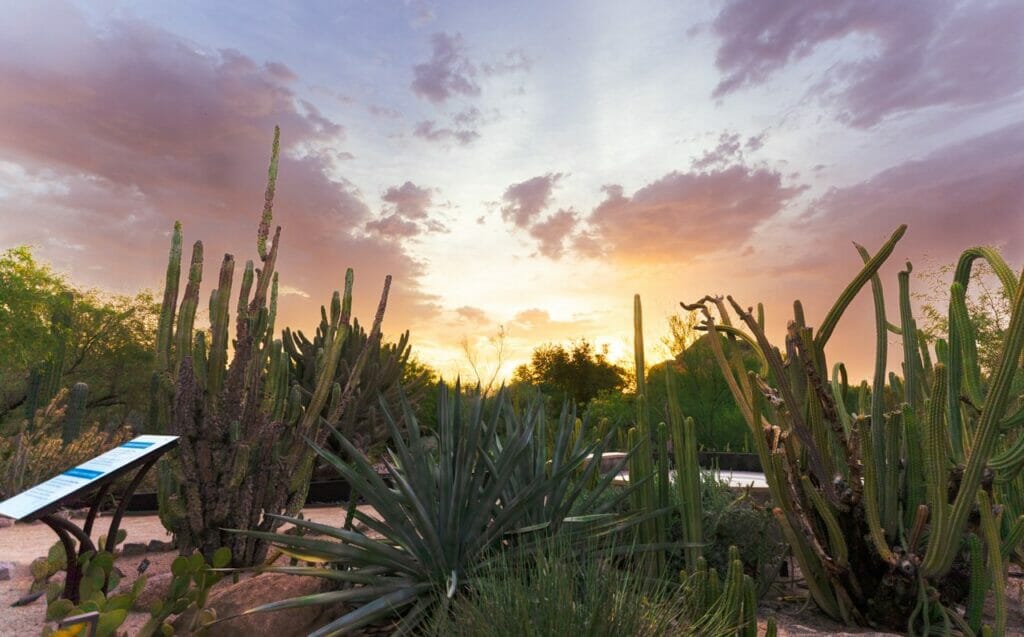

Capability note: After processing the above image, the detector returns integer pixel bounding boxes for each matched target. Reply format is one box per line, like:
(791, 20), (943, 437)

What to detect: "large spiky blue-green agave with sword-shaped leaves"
(230, 384), (664, 636)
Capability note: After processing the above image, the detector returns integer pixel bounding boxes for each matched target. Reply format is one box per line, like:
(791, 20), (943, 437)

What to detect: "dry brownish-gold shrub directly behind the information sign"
(0, 390), (132, 500)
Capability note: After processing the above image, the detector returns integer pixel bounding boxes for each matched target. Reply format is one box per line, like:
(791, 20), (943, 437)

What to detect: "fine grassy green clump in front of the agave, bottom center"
(429, 542), (716, 637)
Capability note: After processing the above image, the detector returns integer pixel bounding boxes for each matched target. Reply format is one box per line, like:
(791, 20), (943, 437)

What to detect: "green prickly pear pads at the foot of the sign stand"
(43, 551), (140, 637)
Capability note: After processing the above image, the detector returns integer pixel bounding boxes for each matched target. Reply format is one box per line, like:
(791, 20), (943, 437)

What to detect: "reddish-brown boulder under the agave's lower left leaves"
(174, 572), (343, 637)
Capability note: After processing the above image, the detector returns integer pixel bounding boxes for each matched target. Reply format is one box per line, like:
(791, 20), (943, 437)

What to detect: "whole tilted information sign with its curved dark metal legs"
(0, 435), (178, 604)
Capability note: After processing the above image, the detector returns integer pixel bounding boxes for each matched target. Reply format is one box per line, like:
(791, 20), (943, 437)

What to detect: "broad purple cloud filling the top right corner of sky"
(713, 0), (1024, 128)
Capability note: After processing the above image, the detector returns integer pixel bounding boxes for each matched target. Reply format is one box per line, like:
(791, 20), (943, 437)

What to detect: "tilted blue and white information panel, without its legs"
(0, 435), (178, 520)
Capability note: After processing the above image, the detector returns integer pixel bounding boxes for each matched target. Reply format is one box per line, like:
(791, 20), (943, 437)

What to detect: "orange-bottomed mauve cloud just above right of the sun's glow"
(574, 164), (804, 262)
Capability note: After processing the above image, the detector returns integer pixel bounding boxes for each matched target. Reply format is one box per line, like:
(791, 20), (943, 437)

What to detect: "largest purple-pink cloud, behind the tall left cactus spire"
(0, 9), (431, 325)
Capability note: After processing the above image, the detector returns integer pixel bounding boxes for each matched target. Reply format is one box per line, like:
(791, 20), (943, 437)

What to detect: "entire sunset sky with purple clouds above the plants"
(0, 0), (1024, 380)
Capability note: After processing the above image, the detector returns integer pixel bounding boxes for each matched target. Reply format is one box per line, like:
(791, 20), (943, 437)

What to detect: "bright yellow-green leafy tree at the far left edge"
(0, 247), (156, 432)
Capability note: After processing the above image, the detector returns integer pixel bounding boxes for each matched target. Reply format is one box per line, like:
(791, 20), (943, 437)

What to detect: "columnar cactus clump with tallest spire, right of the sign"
(151, 130), (390, 565)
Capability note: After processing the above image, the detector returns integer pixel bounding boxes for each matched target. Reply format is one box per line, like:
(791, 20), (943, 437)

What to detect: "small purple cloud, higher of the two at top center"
(412, 33), (480, 103)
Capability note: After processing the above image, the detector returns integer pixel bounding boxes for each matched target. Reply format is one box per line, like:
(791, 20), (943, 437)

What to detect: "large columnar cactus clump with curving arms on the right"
(683, 226), (1024, 634)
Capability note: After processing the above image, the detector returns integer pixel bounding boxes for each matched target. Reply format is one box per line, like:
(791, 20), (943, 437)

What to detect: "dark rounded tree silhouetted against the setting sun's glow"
(514, 339), (629, 407)
